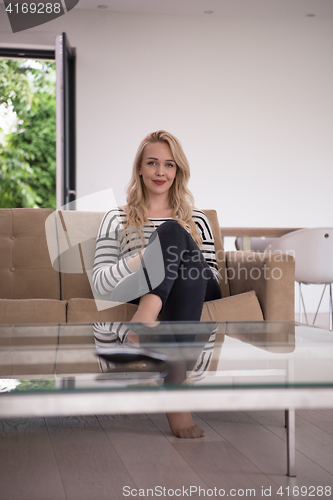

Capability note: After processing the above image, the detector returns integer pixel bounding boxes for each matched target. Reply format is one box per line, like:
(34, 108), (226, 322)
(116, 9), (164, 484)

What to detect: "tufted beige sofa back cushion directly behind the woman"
(50, 210), (230, 300)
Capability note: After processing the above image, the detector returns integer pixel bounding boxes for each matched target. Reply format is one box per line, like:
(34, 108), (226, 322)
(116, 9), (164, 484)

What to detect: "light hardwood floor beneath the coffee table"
(0, 410), (333, 500)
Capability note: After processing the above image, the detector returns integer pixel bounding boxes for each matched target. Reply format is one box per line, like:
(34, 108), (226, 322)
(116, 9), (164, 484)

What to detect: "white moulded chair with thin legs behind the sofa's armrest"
(265, 228), (333, 330)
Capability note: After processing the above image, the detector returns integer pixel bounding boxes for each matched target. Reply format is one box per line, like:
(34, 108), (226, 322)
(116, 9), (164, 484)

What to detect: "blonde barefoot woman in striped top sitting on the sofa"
(93, 130), (221, 437)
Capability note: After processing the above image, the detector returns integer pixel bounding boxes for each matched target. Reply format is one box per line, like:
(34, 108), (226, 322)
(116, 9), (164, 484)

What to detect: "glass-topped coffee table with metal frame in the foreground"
(0, 322), (333, 476)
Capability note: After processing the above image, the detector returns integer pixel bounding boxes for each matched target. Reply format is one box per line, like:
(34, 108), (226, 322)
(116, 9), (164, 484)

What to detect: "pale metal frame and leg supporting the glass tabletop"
(0, 380), (333, 476)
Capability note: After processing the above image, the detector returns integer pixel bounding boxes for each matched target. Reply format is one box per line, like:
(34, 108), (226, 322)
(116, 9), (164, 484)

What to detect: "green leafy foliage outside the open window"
(0, 59), (56, 208)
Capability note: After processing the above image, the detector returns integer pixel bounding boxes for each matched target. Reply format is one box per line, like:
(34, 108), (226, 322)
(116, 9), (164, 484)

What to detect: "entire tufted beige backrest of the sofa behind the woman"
(0, 208), (230, 300)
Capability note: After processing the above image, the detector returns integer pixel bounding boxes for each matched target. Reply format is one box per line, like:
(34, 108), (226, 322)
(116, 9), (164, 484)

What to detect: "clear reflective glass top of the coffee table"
(0, 321), (333, 394)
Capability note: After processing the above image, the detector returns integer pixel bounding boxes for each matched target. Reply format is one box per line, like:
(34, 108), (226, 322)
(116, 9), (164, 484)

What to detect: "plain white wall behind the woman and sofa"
(0, 5), (333, 312)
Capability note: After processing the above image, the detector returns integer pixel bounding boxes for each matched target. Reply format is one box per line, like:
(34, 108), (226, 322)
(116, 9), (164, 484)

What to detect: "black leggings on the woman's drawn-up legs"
(115, 220), (221, 321)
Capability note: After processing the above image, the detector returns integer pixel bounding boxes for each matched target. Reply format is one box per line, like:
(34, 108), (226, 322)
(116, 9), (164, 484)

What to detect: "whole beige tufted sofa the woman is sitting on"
(0, 208), (295, 324)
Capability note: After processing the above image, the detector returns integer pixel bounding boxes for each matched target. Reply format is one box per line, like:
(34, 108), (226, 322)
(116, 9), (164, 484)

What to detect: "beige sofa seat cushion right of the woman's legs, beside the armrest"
(201, 291), (264, 321)
